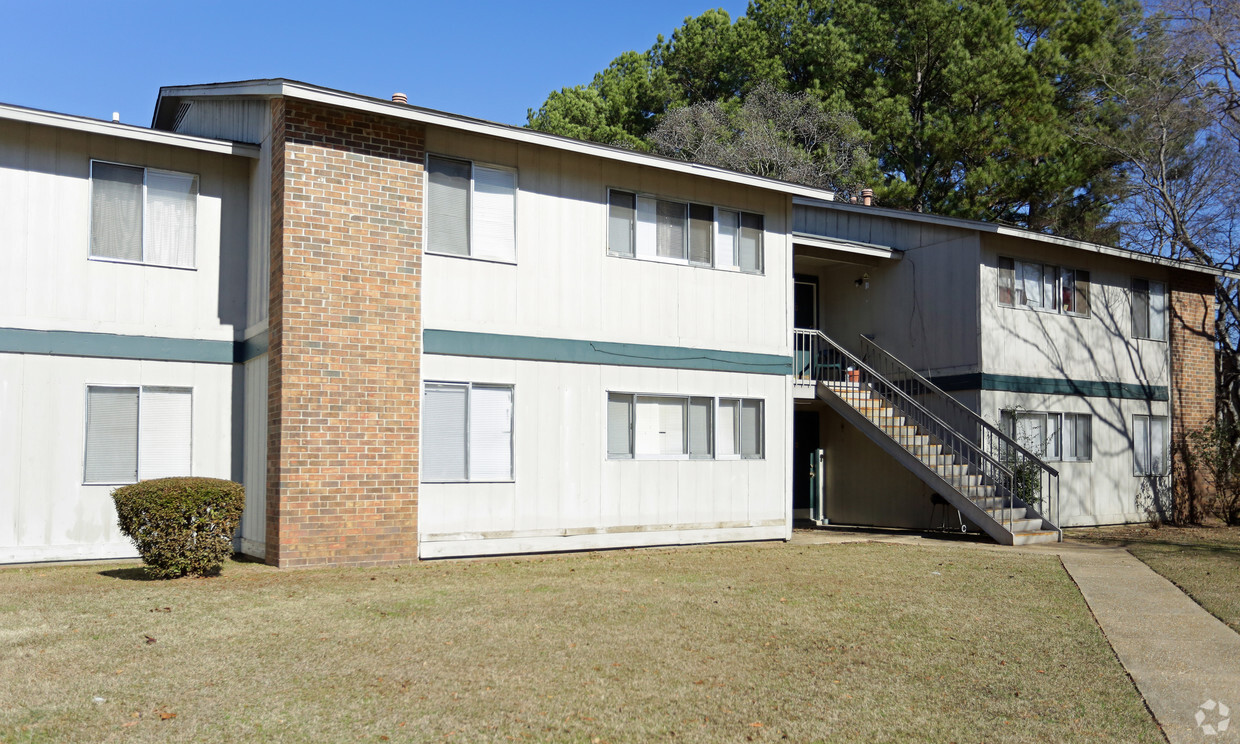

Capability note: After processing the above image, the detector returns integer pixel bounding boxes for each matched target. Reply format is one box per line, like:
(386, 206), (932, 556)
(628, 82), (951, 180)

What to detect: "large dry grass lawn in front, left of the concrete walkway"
(0, 543), (1162, 744)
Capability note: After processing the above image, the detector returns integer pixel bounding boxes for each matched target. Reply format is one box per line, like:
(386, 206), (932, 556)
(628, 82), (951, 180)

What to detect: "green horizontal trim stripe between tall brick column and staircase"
(422, 330), (792, 374)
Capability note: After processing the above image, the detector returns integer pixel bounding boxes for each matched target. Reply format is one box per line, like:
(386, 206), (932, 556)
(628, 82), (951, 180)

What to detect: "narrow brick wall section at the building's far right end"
(1171, 274), (1215, 520)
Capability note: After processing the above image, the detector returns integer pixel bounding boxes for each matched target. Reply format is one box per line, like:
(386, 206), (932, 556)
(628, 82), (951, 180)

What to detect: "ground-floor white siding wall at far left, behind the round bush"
(0, 353), (232, 563)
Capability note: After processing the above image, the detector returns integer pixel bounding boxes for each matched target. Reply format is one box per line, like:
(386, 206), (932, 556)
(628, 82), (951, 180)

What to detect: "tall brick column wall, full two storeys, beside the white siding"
(267, 99), (424, 567)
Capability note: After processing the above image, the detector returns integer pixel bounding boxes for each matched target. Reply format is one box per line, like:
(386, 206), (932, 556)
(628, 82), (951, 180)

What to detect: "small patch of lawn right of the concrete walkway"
(1064, 523), (1240, 632)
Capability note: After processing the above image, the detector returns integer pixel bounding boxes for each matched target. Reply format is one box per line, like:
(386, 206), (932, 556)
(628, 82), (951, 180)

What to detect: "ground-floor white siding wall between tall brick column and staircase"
(418, 356), (791, 557)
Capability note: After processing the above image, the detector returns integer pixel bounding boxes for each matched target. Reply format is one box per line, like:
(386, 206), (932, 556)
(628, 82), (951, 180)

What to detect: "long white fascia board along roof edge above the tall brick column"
(156, 81), (835, 201)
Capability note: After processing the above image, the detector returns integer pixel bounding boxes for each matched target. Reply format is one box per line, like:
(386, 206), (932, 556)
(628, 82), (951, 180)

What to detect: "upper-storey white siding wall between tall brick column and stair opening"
(423, 128), (791, 353)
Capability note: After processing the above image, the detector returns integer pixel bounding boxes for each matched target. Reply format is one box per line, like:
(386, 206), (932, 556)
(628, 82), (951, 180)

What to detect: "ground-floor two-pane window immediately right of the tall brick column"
(422, 382), (513, 482)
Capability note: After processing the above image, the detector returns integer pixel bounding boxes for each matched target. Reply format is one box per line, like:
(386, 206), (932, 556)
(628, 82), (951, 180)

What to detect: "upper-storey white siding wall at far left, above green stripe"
(0, 122), (249, 341)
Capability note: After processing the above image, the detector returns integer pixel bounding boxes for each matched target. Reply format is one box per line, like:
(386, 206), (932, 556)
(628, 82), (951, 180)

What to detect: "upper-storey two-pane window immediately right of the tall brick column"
(427, 155), (517, 263)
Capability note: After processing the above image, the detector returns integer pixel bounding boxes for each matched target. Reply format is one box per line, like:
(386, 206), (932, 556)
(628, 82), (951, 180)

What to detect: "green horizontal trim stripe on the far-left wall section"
(0, 329), (236, 365)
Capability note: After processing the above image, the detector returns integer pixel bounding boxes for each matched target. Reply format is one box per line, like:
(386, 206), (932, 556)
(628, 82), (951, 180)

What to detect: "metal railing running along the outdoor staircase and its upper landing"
(794, 329), (1059, 532)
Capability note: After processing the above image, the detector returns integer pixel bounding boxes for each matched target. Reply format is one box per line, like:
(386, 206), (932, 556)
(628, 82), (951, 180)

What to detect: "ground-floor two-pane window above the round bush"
(82, 384), (193, 485)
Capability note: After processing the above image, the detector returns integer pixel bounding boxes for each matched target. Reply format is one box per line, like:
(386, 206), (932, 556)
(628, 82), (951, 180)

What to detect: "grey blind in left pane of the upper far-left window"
(91, 162), (144, 262)
